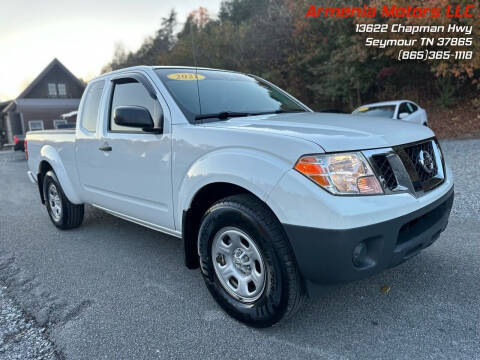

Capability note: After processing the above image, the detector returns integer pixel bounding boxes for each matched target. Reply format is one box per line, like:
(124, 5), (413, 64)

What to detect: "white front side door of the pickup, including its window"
(86, 74), (174, 229)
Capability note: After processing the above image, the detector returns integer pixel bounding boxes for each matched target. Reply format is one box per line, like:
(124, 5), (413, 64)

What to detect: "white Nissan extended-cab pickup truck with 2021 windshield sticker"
(27, 66), (453, 327)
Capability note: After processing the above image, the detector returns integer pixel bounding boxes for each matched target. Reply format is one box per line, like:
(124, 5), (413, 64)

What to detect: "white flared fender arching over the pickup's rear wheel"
(37, 145), (82, 204)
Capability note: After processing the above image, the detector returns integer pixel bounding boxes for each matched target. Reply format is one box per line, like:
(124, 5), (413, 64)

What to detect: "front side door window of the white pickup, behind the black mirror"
(108, 78), (161, 133)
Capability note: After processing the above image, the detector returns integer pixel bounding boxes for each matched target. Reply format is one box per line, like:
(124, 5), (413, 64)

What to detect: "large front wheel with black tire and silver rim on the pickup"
(198, 194), (305, 328)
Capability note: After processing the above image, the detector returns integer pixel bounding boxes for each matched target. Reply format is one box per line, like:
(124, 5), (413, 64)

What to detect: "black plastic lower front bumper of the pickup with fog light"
(284, 187), (454, 285)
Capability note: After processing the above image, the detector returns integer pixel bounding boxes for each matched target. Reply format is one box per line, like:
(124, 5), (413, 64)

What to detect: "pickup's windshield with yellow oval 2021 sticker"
(155, 68), (308, 122)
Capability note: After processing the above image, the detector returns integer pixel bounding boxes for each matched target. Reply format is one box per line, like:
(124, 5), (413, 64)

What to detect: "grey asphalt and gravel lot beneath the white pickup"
(0, 140), (480, 360)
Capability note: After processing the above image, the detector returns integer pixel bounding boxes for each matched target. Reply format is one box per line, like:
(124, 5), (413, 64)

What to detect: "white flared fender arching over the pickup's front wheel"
(175, 148), (292, 224)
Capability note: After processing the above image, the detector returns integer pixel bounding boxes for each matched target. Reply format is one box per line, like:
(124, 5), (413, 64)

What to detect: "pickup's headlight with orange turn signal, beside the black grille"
(295, 152), (383, 195)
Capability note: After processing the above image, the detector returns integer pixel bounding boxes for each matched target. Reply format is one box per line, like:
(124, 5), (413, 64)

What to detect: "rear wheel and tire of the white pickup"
(43, 171), (84, 230)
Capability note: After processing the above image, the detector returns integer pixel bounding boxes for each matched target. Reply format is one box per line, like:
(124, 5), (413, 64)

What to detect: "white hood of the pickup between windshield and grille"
(204, 112), (434, 152)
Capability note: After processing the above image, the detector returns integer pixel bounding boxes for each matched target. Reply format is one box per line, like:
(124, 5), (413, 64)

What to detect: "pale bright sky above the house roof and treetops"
(0, 0), (221, 101)
